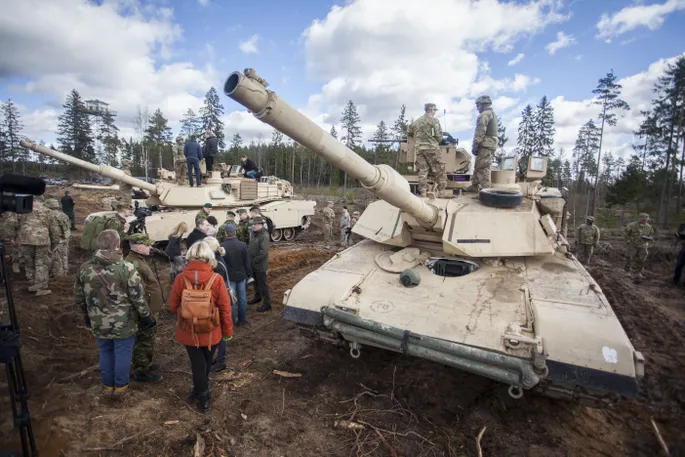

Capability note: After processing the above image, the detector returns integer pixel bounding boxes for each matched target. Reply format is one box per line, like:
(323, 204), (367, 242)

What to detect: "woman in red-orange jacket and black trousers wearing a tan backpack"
(169, 241), (233, 413)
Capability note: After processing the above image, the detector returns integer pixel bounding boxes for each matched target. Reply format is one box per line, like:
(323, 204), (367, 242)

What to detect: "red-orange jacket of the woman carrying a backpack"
(169, 261), (233, 347)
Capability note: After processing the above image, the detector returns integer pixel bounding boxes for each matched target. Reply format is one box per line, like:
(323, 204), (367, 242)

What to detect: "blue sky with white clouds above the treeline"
(0, 0), (685, 164)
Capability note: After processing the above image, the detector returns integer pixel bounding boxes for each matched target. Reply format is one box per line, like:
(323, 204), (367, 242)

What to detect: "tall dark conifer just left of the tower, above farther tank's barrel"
(57, 89), (96, 168)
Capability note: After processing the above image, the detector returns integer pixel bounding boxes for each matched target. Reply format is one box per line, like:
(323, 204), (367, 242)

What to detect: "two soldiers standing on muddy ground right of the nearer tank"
(576, 213), (654, 277)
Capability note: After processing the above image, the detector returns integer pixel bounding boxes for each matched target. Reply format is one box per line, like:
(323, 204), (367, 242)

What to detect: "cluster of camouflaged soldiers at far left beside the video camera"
(0, 194), (75, 297)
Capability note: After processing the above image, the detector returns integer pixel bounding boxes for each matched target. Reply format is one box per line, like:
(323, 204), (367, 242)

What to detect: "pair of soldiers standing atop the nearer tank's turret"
(407, 95), (499, 197)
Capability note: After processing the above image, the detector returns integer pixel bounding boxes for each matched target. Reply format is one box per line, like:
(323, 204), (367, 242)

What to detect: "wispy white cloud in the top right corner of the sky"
(597, 0), (685, 43)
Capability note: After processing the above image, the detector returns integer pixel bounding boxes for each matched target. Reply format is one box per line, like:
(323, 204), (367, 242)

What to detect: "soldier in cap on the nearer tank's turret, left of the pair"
(407, 103), (447, 197)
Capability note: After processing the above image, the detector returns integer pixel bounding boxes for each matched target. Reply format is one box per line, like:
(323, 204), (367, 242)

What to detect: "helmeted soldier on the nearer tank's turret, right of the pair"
(469, 95), (499, 190)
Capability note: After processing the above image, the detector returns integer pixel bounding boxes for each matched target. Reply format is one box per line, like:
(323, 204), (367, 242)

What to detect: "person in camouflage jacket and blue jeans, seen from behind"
(74, 230), (156, 396)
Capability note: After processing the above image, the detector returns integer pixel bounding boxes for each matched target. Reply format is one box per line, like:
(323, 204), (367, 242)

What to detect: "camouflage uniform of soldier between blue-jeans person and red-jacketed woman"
(126, 244), (164, 372)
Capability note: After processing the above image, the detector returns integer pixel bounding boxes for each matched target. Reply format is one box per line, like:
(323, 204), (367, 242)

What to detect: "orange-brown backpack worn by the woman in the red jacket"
(177, 273), (221, 349)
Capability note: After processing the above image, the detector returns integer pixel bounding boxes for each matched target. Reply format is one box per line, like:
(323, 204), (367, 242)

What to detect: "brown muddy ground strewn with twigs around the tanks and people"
(0, 191), (685, 457)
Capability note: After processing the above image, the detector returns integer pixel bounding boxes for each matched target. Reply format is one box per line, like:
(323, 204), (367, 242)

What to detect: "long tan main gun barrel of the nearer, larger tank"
(224, 69), (438, 227)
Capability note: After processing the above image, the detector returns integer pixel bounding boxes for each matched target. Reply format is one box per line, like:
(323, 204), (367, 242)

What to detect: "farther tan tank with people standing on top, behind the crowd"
(21, 140), (316, 241)
